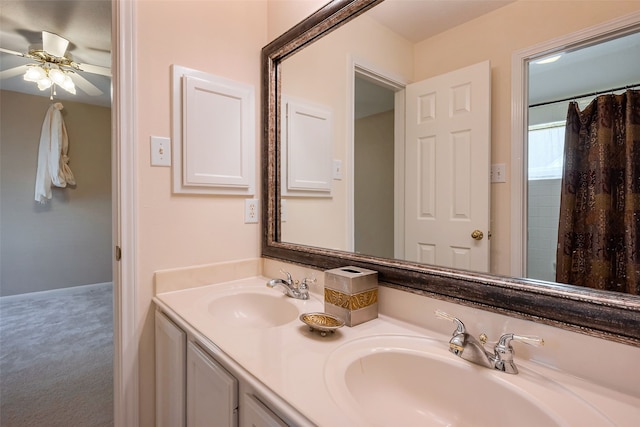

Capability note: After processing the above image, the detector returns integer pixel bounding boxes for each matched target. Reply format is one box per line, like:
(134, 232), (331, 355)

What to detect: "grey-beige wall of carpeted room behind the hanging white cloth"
(0, 91), (112, 296)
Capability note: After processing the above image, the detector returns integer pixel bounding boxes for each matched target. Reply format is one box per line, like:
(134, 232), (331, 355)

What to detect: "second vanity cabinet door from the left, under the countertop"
(187, 342), (238, 427)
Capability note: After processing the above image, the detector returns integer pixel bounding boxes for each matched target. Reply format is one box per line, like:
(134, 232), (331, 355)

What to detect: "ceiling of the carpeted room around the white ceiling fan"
(0, 0), (111, 106)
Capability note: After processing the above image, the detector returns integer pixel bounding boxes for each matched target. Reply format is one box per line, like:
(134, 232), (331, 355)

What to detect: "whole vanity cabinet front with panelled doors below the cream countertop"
(155, 310), (295, 427)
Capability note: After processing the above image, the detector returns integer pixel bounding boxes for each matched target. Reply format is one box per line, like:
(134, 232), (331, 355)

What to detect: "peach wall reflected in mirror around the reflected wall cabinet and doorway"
(282, 11), (413, 250)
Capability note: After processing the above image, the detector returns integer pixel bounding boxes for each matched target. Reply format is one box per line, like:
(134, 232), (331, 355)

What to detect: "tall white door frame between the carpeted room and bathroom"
(111, 0), (141, 427)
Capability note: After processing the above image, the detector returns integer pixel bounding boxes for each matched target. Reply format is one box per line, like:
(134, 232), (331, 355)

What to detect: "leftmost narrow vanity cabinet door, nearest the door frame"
(155, 311), (187, 427)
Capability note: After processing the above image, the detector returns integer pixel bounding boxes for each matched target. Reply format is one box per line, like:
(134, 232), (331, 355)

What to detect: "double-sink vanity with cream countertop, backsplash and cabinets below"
(154, 260), (640, 427)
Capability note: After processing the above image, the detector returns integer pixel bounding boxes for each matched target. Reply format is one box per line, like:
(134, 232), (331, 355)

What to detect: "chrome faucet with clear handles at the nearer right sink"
(436, 310), (544, 374)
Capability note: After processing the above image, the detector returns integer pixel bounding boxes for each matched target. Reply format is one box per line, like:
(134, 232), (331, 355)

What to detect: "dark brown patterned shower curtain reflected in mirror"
(556, 90), (640, 295)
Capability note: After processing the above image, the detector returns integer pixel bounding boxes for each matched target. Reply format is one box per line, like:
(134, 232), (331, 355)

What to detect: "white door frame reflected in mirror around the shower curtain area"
(509, 12), (640, 277)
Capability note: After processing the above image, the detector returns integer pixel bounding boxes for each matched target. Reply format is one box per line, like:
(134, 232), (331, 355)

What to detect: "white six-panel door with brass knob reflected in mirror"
(405, 61), (491, 272)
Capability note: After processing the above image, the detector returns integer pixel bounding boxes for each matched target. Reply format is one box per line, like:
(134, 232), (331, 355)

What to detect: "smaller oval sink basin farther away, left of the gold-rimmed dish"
(209, 292), (300, 328)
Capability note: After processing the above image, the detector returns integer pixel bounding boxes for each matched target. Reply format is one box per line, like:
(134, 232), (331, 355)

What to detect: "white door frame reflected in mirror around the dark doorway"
(345, 56), (409, 254)
